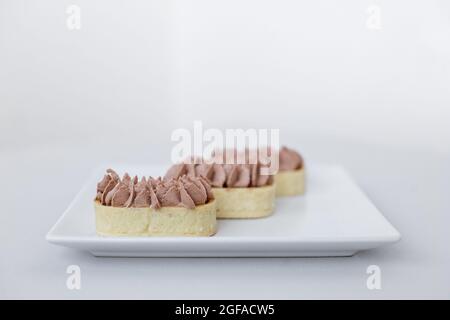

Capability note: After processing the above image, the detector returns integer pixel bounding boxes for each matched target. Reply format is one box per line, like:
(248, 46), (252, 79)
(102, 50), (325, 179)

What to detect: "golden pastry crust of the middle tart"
(212, 184), (275, 219)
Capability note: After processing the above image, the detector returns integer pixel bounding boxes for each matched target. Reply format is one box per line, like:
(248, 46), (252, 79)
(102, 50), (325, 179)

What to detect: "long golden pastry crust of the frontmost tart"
(94, 201), (217, 236)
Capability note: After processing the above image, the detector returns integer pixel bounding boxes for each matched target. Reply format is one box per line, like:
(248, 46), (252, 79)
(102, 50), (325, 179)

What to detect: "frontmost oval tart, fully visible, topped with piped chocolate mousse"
(94, 169), (216, 236)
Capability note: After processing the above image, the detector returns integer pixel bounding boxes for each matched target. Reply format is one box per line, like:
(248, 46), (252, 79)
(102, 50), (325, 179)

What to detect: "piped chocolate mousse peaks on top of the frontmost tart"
(95, 169), (214, 209)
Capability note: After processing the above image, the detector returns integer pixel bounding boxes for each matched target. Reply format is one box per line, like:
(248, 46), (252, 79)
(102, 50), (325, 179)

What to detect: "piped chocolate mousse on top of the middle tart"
(164, 162), (273, 188)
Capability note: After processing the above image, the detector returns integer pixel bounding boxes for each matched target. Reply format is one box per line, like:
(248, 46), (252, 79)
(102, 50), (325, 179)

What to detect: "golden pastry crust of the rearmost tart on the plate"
(275, 167), (305, 197)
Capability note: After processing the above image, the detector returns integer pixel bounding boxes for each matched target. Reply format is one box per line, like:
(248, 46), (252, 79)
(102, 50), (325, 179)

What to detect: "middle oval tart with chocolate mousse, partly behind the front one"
(164, 163), (275, 218)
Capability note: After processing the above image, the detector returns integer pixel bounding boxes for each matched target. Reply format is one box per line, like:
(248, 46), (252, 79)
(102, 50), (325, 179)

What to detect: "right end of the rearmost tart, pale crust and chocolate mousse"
(275, 147), (305, 197)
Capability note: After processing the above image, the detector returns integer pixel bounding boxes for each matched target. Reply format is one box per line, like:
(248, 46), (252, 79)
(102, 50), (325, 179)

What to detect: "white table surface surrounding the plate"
(0, 140), (450, 299)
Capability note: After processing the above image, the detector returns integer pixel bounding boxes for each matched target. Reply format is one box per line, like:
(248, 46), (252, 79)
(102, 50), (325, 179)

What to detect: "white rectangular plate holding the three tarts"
(47, 165), (400, 257)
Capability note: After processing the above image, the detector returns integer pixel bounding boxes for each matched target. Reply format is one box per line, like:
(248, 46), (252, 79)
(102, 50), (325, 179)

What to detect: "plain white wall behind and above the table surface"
(0, 0), (450, 153)
